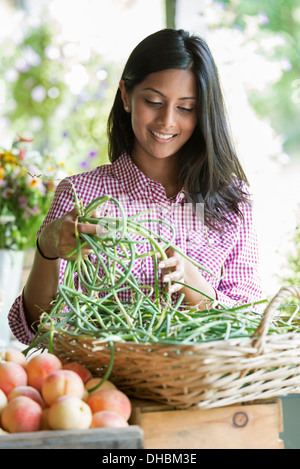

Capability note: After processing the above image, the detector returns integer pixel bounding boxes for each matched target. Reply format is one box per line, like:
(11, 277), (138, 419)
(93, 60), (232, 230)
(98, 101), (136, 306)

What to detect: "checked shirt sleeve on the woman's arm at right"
(216, 199), (263, 307)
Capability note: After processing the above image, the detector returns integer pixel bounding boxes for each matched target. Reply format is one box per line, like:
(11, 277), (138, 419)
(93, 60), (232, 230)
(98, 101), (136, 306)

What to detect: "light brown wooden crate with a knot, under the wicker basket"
(130, 399), (284, 449)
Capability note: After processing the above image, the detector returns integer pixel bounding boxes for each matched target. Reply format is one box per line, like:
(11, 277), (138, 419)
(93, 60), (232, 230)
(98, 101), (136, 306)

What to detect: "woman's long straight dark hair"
(108, 29), (248, 229)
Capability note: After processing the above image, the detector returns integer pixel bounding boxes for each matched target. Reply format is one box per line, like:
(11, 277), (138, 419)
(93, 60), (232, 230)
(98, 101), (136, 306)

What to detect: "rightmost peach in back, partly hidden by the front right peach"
(87, 389), (131, 421)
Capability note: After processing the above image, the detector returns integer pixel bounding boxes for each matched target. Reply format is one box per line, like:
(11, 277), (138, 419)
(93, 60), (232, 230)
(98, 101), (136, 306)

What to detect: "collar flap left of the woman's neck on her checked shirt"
(112, 152), (185, 203)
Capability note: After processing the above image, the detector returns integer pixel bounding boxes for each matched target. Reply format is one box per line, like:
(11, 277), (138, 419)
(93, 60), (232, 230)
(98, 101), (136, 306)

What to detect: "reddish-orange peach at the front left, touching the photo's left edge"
(1, 396), (42, 433)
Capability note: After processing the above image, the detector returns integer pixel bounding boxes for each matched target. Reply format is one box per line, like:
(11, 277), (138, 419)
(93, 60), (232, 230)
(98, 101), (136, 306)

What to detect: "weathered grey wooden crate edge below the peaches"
(0, 425), (143, 450)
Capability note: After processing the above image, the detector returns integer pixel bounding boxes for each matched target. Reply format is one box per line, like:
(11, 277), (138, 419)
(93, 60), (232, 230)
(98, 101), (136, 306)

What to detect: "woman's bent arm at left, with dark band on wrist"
(8, 173), (101, 344)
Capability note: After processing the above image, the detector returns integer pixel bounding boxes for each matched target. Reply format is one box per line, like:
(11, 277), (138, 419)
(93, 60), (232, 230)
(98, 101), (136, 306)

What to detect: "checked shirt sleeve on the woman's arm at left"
(8, 179), (75, 345)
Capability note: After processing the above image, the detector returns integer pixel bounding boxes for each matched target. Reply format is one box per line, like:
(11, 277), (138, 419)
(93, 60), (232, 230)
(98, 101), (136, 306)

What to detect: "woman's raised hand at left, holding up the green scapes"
(39, 208), (97, 260)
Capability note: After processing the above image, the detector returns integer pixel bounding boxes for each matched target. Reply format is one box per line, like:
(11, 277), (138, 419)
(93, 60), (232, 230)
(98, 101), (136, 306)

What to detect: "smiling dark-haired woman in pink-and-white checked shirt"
(9, 29), (261, 343)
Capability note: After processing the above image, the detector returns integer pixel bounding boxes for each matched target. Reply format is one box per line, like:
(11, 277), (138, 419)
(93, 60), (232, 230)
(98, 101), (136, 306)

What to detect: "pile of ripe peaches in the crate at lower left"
(0, 348), (131, 438)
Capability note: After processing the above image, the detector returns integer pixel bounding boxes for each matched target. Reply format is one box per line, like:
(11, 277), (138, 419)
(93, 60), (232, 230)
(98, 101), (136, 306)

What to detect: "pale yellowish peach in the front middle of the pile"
(48, 395), (92, 430)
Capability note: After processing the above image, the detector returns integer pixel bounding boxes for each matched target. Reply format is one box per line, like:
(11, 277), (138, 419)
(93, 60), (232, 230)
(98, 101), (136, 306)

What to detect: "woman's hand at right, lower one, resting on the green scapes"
(158, 247), (216, 309)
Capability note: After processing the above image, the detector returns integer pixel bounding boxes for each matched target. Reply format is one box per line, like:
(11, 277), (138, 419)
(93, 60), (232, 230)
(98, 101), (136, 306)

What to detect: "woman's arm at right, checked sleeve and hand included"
(160, 199), (263, 309)
